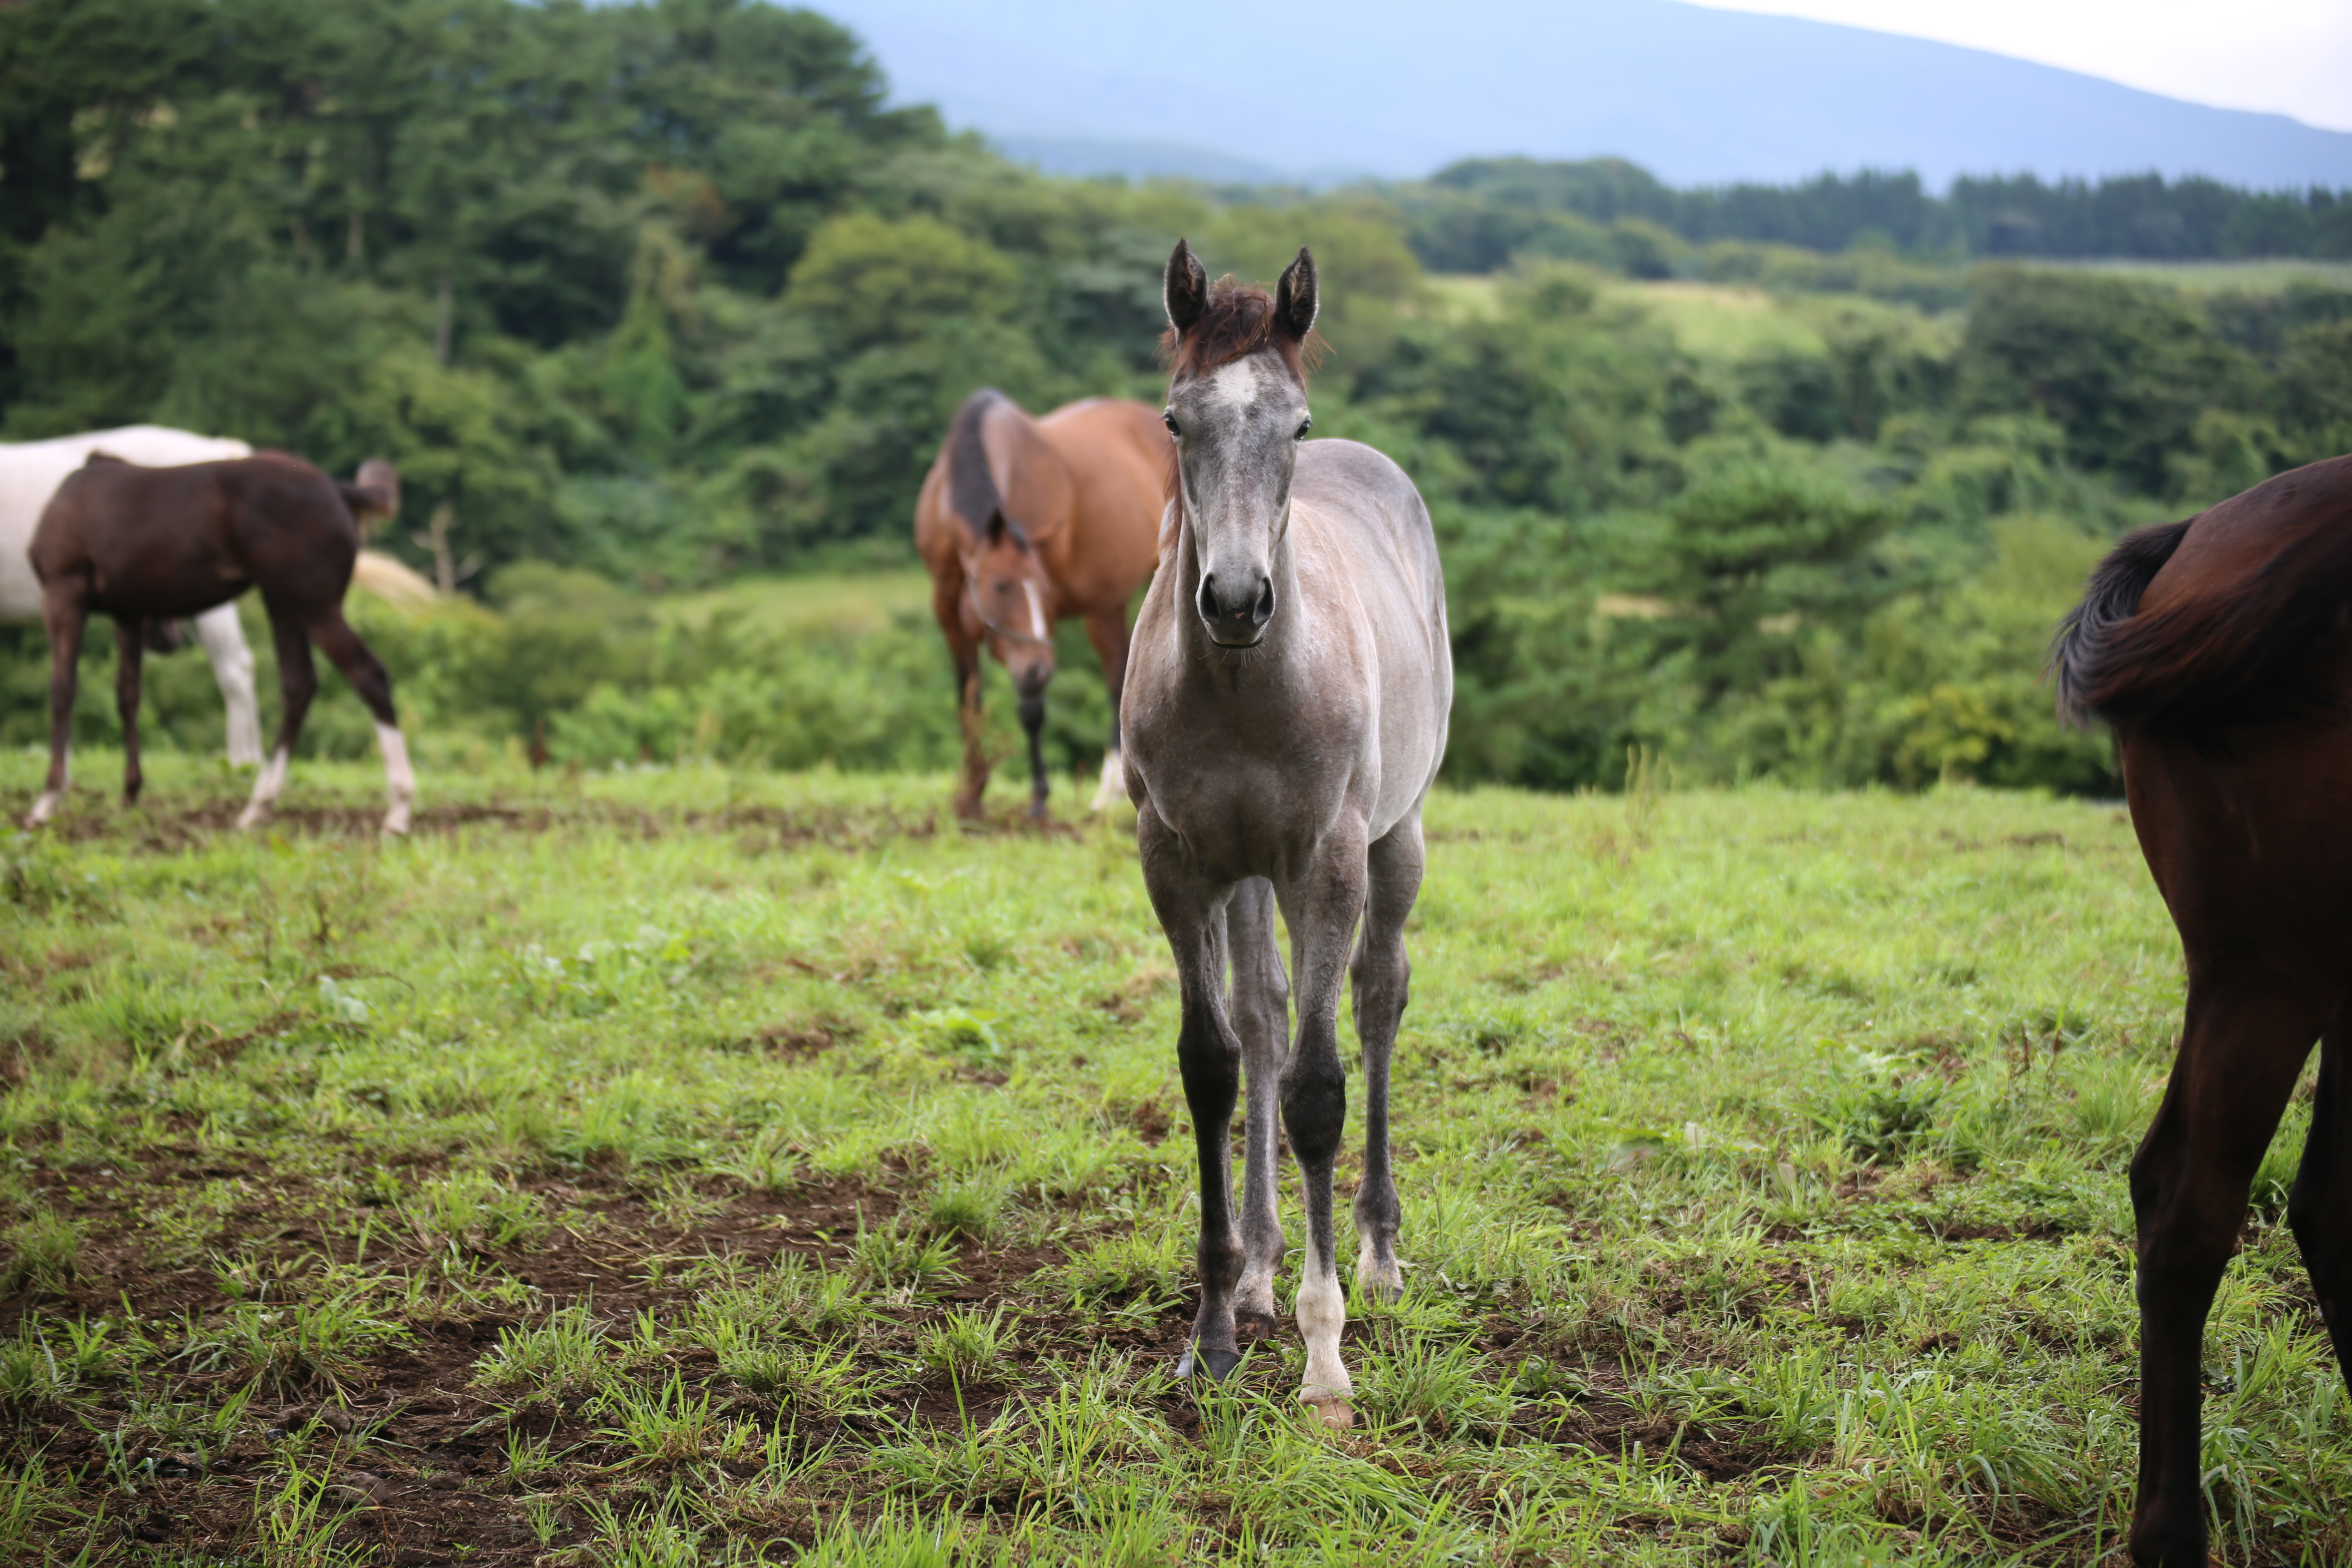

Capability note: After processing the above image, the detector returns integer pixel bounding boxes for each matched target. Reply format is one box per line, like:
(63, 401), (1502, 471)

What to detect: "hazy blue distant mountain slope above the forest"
(814, 0), (2352, 188)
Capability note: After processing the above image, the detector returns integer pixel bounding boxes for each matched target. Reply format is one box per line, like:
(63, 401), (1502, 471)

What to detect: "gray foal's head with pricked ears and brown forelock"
(1164, 240), (1315, 649)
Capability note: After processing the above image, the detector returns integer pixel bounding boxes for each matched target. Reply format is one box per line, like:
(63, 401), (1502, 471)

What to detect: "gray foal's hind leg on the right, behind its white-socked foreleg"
(1348, 811), (1423, 1300)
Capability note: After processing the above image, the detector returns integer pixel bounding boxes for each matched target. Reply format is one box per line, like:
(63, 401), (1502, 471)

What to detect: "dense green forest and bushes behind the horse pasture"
(0, 0), (2352, 795)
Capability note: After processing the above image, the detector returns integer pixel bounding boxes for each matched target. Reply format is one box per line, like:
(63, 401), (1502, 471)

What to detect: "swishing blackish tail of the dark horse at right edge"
(2051, 519), (2352, 731)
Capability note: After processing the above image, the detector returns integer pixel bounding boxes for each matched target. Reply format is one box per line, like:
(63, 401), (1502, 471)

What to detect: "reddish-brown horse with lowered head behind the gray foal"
(915, 388), (1174, 818)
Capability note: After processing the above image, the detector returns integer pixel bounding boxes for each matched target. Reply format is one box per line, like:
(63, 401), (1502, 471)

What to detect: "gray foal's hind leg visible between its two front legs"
(1225, 877), (1291, 1345)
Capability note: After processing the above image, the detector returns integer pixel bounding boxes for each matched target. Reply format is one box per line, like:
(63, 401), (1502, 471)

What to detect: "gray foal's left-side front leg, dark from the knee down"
(1136, 806), (1242, 1378)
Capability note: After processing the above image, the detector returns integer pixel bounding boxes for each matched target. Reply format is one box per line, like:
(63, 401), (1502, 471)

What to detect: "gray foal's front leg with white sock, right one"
(1282, 828), (1364, 1427)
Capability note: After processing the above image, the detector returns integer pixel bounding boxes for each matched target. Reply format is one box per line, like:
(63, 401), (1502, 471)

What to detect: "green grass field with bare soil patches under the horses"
(0, 752), (2352, 1568)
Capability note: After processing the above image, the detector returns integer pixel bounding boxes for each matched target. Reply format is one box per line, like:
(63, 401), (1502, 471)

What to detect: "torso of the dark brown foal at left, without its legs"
(26, 451), (360, 616)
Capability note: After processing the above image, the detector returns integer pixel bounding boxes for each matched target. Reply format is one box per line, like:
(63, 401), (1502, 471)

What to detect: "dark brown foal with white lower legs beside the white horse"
(26, 451), (416, 832)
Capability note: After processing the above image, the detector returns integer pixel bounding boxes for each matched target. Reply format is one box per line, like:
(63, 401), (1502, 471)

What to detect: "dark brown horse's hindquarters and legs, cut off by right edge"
(2051, 456), (2352, 1568)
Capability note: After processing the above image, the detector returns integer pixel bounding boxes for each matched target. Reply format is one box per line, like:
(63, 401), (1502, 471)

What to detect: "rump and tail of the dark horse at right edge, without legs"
(2051, 456), (2352, 733)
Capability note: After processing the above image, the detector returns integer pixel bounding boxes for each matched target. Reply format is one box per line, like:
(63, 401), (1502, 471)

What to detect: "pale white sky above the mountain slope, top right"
(1698, 0), (2352, 131)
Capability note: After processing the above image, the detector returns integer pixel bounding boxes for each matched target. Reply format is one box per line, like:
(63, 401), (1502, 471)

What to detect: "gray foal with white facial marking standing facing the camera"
(1120, 240), (1454, 1427)
